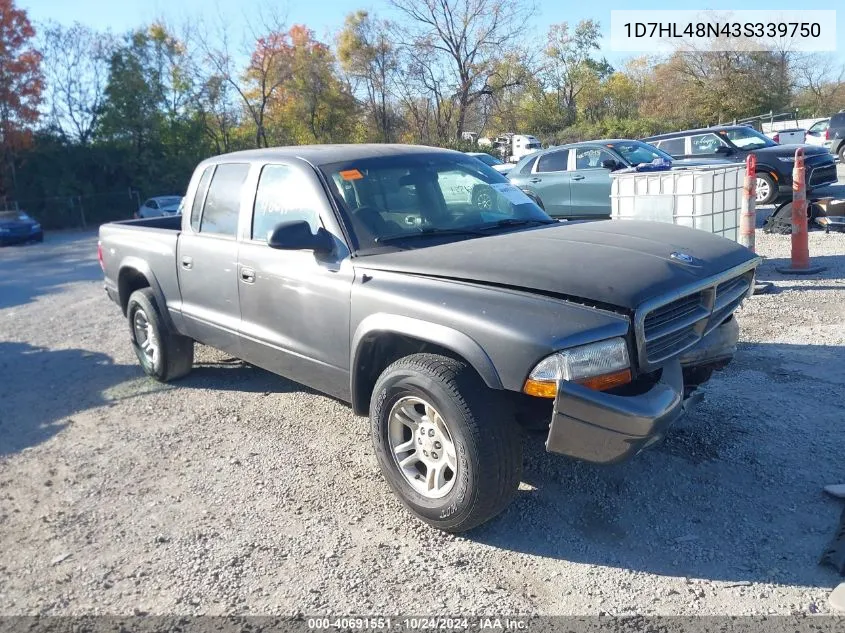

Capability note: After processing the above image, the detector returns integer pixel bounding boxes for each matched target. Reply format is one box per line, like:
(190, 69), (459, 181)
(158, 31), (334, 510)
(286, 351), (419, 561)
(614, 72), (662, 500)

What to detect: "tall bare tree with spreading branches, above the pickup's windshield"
(391, 0), (533, 139)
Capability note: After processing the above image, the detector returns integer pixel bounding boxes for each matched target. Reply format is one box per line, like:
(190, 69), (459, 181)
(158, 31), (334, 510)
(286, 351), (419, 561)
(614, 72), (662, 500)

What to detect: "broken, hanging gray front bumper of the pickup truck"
(546, 319), (739, 464)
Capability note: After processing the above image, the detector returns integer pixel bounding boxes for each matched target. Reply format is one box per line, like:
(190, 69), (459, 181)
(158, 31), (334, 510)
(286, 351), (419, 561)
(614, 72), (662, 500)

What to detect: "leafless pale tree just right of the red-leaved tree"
(42, 22), (114, 145)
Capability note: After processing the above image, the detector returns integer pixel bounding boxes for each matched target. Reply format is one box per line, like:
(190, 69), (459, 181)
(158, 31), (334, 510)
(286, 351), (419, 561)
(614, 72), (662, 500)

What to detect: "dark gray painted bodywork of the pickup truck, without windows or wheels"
(100, 146), (759, 461)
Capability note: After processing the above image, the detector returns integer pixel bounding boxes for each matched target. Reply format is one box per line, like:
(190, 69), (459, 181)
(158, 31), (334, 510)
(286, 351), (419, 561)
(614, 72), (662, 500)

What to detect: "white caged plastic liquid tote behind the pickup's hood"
(610, 164), (744, 241)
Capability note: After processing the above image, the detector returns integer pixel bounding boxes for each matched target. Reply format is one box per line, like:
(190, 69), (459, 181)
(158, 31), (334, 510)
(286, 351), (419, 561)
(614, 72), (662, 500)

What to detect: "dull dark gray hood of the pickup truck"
(355, 220), (758, 310)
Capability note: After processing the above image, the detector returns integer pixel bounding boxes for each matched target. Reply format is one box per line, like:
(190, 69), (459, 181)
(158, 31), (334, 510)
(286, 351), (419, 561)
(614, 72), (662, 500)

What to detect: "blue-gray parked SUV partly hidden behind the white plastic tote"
(508, 139), (724, 219)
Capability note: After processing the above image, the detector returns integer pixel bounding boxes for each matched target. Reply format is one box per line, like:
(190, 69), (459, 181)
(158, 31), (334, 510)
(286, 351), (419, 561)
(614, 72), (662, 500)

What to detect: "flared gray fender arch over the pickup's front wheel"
(349, 314), (504, 415)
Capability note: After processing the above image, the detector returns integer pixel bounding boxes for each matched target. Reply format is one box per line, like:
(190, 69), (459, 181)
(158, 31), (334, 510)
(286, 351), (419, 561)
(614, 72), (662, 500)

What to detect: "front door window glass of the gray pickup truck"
(252, 165), (320, 241)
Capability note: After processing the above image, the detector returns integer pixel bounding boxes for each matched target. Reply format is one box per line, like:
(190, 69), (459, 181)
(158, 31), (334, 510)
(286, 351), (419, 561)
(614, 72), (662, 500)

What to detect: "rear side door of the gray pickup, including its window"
(176, 163), (250, 357)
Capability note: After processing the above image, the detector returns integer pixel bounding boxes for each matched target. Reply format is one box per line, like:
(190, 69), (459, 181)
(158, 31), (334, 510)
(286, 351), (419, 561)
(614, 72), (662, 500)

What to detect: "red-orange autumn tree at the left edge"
(0, 0), (43, 195)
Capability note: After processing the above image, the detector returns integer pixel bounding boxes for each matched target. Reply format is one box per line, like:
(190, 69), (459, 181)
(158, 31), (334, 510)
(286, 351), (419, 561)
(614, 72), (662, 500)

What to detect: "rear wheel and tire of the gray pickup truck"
(126, 288), (194, 382)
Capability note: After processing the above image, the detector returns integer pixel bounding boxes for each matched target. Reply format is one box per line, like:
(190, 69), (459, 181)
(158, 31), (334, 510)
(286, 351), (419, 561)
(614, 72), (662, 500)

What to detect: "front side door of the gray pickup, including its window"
(237, 164), (353, 400)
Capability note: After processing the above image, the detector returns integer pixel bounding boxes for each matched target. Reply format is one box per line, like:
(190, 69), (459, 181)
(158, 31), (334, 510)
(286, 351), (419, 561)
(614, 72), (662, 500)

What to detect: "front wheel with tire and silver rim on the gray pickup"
(370, 354), (522, 533)
